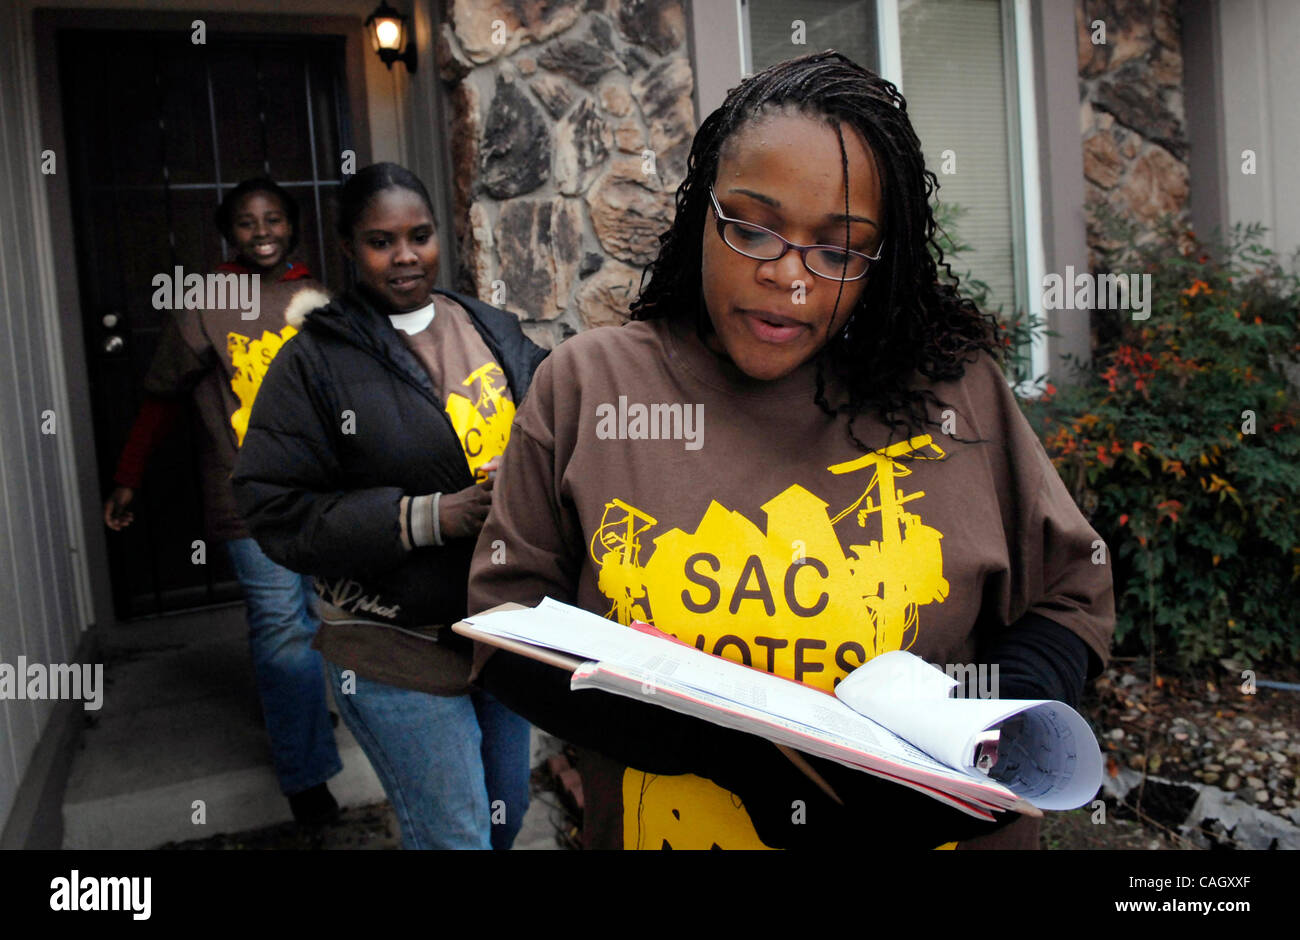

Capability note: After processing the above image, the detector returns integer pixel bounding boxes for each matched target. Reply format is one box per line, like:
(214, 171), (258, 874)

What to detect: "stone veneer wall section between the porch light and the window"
(438, 0), (694, 347)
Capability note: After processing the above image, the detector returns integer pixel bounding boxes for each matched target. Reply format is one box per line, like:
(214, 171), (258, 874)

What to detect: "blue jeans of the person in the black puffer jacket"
(326, 663), (529, 849)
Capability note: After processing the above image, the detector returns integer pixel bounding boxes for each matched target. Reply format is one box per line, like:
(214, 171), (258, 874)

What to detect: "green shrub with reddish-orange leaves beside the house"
(1023, 220), (1300, 666)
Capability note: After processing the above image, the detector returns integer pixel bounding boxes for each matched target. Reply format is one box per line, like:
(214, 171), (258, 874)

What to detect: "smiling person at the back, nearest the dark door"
(104, 179), (342, 824)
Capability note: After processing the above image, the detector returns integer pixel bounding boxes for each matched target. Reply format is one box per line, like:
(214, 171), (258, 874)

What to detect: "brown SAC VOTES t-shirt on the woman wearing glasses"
(469, 315), (1114, 848)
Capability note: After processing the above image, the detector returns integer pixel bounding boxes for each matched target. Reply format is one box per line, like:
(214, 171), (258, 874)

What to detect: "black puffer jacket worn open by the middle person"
(233, 283), (546, 627)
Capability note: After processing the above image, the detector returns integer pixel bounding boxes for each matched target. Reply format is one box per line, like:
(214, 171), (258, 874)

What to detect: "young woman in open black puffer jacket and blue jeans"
(234, 164), (545, 849)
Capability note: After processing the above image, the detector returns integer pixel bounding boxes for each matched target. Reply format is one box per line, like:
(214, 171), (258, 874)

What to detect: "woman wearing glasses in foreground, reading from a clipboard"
(469, 53), (1113, 849)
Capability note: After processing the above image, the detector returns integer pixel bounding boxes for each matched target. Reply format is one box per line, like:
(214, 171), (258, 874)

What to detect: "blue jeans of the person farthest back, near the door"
(226, 538), (343, 796)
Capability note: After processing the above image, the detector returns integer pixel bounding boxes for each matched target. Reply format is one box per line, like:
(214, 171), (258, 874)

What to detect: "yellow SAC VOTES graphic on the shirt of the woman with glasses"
(590, 434), (949, 848)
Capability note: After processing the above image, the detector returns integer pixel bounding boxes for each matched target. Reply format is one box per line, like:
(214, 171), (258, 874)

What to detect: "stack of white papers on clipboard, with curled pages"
(454, 598), (1101, 819)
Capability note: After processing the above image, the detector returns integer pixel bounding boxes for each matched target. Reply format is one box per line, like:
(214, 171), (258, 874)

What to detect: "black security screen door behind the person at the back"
(59, 30), (352, 619)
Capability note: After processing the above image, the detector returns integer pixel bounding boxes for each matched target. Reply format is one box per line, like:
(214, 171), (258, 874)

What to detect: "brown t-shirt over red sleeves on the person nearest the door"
(143, 272), (329, 541)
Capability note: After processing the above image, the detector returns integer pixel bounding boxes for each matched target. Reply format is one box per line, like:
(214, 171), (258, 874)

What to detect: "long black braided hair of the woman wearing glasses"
(631, 51), (1001, 451)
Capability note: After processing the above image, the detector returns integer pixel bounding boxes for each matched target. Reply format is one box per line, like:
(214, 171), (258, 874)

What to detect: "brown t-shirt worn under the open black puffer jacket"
(315, 295), (515, 696)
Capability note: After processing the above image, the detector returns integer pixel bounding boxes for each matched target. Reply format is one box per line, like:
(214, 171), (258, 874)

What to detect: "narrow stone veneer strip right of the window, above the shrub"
(1075, 0), (1188, 270)
